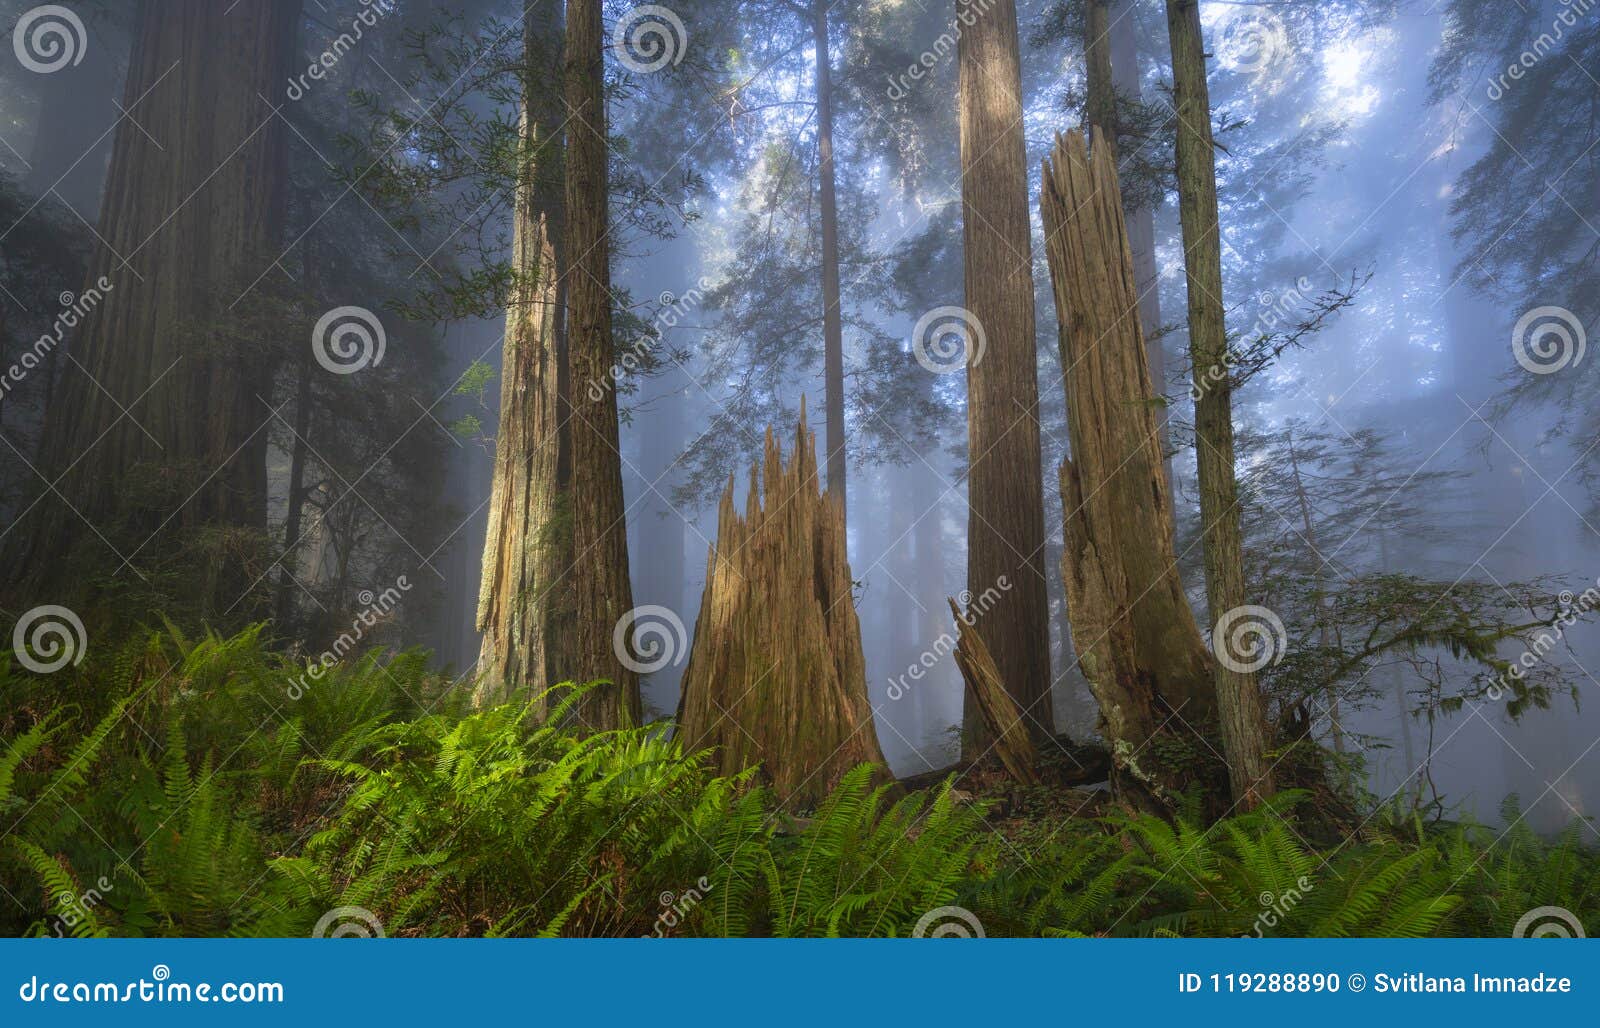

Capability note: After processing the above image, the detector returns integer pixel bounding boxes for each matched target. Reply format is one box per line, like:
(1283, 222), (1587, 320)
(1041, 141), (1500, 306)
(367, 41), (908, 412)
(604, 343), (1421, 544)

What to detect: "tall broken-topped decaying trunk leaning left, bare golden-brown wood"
(1040, 126), (1214, 804)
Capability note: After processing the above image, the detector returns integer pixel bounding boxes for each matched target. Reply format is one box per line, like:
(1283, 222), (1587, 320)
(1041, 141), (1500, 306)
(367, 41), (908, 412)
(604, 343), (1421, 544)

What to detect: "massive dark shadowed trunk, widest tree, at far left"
(7, 0), (300, 618)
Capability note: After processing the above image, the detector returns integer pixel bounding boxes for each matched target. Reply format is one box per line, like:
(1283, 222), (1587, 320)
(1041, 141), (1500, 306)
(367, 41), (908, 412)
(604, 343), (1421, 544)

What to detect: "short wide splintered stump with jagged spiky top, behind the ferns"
(678, 400), (886, 810)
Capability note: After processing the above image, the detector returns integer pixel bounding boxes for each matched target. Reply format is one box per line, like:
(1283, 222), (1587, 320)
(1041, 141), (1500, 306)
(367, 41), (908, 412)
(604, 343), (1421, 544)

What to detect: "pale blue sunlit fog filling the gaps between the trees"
(0, 0), (1600, 831)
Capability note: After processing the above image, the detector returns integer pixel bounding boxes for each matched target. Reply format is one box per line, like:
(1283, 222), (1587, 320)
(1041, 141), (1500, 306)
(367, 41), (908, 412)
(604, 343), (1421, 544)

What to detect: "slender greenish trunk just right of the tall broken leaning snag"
(1166, 0), (1272, 809)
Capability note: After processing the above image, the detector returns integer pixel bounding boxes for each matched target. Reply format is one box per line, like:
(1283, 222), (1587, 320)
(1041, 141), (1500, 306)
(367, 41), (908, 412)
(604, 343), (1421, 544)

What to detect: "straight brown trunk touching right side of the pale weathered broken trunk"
(565, 0), (640, 730)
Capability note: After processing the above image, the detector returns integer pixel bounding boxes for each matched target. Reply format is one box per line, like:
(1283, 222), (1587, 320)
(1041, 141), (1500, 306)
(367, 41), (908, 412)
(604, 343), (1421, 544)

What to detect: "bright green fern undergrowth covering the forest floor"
(0, 626), (1600, 937)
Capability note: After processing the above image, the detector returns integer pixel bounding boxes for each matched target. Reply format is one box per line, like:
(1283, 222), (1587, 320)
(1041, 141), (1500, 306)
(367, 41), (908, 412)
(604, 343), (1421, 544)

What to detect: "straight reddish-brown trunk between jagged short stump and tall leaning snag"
(958, 0), (1054, 757)
